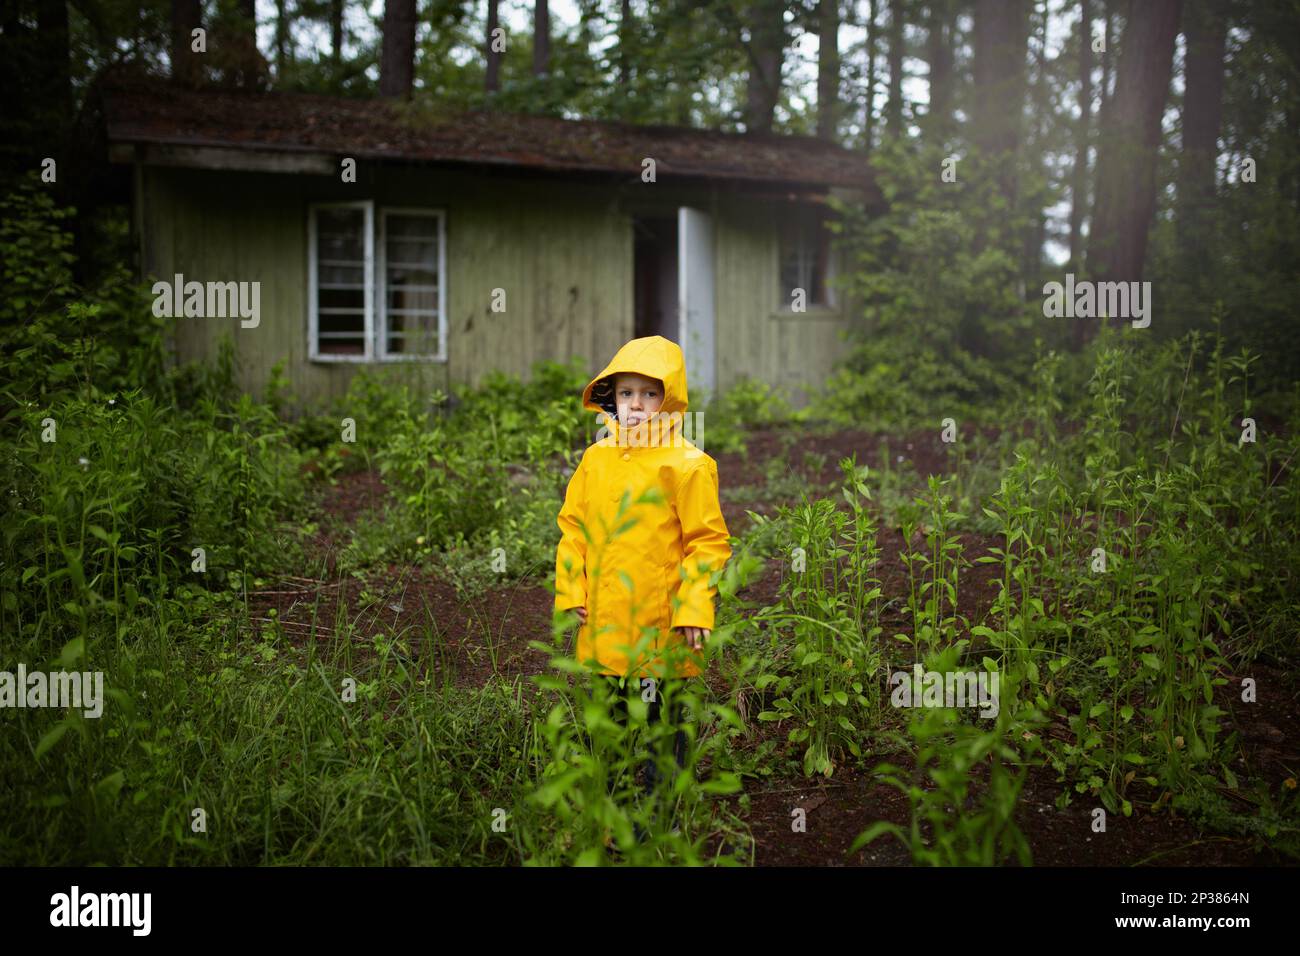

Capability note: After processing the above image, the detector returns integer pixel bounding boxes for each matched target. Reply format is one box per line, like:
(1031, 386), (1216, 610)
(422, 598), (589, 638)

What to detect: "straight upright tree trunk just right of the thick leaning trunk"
(1178, 0), (1227, 276)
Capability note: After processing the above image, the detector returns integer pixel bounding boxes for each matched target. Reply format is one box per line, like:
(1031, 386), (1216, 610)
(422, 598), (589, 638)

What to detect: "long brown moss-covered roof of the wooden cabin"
(103, 78), (880, 202)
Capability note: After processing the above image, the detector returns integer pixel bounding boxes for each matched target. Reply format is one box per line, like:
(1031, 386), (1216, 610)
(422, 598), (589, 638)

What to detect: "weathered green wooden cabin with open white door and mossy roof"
(101, 81), (879, 406)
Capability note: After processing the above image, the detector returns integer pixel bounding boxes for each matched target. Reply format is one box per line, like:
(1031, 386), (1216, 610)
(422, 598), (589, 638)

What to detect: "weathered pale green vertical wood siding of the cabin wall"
(143, 164), (846, 408)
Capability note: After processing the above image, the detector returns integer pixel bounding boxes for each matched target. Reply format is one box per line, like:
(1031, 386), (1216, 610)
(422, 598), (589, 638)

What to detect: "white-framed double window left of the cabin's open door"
(308, 202), (447, 362)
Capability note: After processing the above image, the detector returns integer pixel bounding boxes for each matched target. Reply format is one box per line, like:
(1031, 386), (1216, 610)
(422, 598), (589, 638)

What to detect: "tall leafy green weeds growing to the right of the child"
(722, 325), (1300, 864)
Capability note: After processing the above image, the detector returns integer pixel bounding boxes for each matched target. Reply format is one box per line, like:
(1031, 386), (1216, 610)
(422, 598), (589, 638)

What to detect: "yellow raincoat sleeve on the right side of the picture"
(671, 459), (732, 630)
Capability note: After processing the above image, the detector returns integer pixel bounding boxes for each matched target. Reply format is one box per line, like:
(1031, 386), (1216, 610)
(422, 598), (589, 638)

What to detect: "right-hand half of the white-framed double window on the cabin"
(384, 213), (439, 355)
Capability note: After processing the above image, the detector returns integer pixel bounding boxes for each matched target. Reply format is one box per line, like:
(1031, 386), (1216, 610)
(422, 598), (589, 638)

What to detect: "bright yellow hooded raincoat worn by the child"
(555, 336), (732, 678)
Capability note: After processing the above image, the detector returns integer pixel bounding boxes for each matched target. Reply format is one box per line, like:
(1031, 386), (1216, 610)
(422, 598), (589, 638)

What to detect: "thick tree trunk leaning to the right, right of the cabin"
(1088, 0), (1183, 293)
